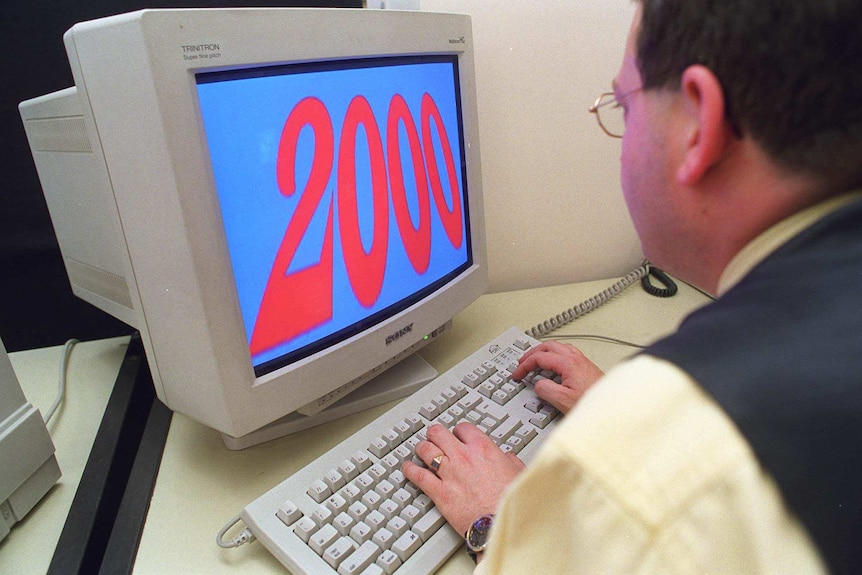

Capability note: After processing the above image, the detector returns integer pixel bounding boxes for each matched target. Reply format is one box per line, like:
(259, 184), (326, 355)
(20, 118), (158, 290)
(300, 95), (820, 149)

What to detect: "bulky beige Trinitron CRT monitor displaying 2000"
(19, 8), (487, 448)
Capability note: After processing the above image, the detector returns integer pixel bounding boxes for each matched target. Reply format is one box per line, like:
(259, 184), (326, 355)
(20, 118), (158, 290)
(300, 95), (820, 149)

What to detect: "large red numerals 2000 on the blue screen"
(250, 94), (464, 354)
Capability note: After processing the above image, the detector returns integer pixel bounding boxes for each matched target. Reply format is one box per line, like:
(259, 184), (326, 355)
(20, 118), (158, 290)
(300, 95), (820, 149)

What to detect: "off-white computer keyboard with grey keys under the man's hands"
(240, 328), (559, 575)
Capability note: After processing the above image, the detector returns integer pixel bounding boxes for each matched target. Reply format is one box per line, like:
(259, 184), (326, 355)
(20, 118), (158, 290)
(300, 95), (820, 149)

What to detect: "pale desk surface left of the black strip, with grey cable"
(0, 337), (129, 575)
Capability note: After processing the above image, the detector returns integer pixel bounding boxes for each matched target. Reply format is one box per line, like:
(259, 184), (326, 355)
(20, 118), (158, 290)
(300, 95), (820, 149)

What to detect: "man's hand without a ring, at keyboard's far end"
(512, 341), (604, 414)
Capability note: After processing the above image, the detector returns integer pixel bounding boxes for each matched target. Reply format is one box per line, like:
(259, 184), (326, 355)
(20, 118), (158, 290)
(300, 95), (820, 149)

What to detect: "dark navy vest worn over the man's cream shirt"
(646, 197), (862, 574)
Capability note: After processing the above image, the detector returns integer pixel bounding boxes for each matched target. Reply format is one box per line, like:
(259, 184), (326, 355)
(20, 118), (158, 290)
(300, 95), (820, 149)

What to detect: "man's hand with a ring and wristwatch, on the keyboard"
(402, 423), (524, 535)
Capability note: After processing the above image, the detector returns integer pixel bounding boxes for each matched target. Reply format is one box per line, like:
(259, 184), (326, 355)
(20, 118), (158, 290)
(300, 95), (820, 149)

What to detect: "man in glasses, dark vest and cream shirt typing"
(404, 0), (862, 574)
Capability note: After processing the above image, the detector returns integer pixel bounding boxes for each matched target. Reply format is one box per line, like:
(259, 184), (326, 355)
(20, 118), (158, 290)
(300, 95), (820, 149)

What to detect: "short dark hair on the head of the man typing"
(637, 0), (862, 194)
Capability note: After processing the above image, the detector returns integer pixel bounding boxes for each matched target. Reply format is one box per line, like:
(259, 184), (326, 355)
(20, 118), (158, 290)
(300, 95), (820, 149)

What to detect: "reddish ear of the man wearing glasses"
(676, 64), (734, 185)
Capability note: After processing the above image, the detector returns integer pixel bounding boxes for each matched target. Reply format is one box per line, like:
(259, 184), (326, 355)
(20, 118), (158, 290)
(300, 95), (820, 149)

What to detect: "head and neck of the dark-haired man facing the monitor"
(614, 0), (862, 291)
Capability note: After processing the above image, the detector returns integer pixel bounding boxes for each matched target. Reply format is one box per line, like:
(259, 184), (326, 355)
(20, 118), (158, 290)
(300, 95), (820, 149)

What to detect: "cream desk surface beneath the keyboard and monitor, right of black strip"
(133, 281), (707, 575)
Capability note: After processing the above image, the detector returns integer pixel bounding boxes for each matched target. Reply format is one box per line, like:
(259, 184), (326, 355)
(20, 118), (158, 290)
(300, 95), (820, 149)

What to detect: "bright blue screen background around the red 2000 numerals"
(198, 59), (470, 366)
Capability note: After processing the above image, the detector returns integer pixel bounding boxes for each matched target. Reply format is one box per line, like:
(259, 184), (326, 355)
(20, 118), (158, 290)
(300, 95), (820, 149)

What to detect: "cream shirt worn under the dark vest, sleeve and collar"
(475, 193), (862, 575)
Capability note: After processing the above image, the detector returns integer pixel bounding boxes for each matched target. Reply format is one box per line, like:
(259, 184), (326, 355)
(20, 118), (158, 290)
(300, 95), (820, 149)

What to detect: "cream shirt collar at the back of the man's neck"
(718, 190), (862, 296)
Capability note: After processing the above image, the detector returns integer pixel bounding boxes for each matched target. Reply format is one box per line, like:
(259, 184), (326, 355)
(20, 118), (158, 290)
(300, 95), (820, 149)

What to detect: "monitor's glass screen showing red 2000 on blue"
(196, 55), (472, 375)
